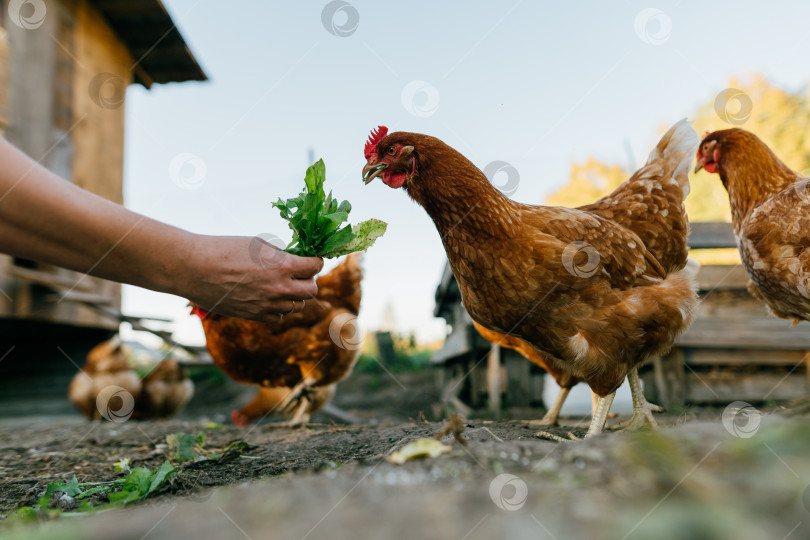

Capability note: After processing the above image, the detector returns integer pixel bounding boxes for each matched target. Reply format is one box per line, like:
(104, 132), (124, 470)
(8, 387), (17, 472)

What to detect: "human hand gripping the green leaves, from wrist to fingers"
(178, 235), (323, 322)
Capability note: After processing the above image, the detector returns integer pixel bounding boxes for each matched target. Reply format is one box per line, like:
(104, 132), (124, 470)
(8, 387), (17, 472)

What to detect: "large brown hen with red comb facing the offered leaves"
(363, 120), (698, 437)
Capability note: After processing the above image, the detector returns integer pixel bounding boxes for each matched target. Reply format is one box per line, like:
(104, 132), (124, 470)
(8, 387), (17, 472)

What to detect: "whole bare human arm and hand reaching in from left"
(0, 138), (323, 322)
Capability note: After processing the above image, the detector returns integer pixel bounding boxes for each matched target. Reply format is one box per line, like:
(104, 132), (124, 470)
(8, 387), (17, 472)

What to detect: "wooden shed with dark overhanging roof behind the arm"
(0, 0), (206, 336)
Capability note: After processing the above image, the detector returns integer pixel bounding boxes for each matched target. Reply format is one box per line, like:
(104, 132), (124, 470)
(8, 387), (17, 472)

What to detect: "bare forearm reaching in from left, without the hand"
(0, 139), (195, 294)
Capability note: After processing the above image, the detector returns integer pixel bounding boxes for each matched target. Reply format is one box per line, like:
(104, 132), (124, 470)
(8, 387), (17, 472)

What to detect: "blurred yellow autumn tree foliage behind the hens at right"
(546, 75), (810, 263)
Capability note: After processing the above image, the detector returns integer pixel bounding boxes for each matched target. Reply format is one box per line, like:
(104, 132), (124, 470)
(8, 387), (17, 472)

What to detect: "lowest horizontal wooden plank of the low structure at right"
(686, 372), (808, 403)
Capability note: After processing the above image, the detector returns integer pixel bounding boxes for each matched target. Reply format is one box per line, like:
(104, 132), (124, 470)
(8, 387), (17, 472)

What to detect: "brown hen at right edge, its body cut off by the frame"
(695, 128), (810, 324)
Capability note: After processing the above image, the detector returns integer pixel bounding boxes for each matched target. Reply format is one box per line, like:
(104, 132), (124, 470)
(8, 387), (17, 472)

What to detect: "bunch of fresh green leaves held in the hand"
(273, 159), (387, 258)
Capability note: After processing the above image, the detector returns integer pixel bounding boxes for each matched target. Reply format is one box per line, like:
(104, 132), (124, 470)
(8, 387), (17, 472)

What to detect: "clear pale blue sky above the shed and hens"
(117, 0), (810, 343)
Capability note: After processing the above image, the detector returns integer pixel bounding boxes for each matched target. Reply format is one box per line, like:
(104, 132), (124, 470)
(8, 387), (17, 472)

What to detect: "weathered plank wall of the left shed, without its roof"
(0, 0), (134, 329)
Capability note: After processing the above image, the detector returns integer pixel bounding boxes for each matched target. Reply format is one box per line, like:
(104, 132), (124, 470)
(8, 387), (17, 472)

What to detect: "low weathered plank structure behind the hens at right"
(639, 223), (810, 407)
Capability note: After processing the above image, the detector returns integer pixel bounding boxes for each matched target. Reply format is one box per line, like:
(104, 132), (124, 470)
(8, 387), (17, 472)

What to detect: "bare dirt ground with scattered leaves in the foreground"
(0, 374), (810, 540)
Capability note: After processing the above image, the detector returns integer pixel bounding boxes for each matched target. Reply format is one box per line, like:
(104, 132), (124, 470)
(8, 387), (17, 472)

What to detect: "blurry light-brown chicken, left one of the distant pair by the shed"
(68, 336), (142, 420)
